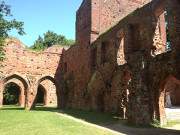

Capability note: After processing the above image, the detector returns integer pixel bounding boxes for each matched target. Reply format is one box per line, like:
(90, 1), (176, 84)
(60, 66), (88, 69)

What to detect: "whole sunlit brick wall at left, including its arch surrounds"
(0, 38), (66, 109)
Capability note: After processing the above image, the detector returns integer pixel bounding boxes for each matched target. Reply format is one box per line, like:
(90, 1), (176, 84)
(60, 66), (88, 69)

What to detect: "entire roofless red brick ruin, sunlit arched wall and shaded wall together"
(0, 0), (180, 125)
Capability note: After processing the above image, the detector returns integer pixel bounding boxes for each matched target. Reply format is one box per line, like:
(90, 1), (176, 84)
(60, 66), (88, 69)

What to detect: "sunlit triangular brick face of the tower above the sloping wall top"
(100, 0), (147, 33)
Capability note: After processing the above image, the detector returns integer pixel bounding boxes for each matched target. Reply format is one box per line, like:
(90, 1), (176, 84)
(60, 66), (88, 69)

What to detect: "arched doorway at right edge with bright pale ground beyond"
(157, 75), (180, 125)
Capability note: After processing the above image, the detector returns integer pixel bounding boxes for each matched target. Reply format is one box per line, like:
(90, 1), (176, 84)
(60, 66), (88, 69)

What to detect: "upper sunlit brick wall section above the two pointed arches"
(3, 40), (62, 75)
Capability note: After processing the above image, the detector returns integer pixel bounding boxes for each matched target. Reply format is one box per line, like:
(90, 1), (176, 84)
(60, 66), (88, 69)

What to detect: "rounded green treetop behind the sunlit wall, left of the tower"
(30, 31), (74, 50)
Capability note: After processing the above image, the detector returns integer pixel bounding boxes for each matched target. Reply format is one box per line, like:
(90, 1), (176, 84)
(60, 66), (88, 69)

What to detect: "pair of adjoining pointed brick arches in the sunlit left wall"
(0, 74), (57, 109)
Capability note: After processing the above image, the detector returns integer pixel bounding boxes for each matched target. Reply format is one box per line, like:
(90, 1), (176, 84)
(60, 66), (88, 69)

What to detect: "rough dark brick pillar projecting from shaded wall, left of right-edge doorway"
(127, 54), (152, 125)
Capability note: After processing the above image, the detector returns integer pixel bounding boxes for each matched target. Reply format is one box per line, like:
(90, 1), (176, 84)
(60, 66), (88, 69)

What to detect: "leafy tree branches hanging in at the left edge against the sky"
(0, 0), (25, 61)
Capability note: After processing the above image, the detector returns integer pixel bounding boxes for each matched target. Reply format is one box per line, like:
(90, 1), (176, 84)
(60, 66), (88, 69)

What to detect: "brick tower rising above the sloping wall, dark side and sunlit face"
(76, 0), (151, 45)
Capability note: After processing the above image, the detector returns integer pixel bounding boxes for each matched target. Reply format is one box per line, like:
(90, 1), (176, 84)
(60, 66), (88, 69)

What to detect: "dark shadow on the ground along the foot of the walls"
(2, 106), (180, 135)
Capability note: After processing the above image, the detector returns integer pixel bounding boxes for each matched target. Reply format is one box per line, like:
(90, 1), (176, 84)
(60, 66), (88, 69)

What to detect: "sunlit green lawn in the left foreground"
(0, 106), (117, 135)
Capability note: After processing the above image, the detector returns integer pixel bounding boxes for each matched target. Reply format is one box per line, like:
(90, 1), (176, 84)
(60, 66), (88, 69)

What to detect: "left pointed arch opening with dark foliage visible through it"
(3, 82), (22, 105)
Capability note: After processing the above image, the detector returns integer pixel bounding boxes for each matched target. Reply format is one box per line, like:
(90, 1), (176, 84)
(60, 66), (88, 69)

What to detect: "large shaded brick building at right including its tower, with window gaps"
(60, 0), (180, 124)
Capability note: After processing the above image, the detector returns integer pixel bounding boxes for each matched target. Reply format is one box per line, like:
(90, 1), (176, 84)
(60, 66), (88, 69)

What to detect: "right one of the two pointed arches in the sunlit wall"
(33, 76), (58, 107)
